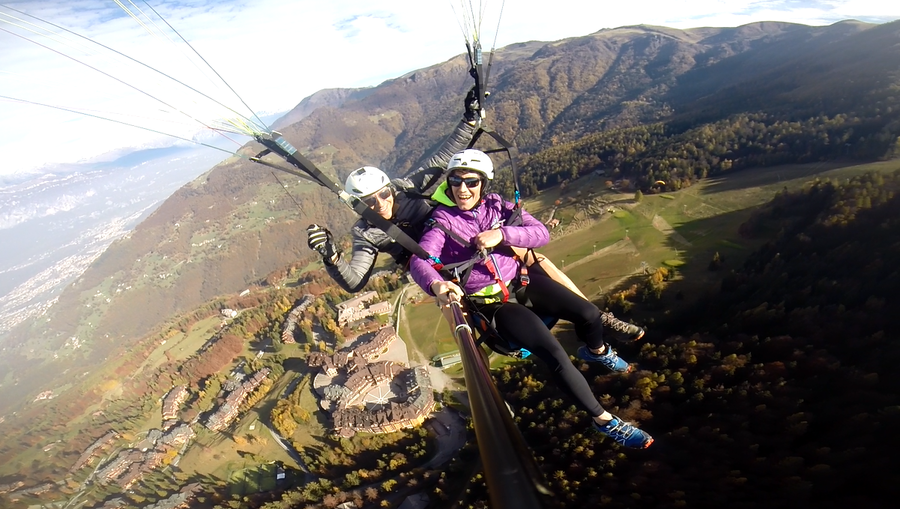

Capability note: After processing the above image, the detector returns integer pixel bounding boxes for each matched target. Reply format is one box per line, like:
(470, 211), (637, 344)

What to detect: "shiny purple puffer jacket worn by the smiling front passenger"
(409, 194), (550, 295)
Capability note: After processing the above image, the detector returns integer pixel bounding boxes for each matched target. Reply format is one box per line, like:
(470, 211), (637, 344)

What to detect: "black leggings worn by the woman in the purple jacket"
(479, 274), (604, 417)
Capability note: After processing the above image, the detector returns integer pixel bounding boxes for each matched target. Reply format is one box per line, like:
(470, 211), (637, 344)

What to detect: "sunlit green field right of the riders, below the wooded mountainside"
(556, 161), (900, 312)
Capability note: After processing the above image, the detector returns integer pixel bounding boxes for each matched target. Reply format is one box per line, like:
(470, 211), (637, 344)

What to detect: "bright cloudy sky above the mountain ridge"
(0, 0), (900, 177)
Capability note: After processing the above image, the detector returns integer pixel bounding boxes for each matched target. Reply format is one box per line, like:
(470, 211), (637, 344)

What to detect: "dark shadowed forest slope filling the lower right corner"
(446, 169), (900, 509)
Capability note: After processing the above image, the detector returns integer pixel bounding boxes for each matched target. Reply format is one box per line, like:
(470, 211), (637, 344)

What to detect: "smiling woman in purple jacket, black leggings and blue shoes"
(410, 149), (653, 449)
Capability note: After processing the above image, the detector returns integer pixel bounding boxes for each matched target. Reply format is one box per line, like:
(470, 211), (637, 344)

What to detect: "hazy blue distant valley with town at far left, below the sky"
(0, 147), (227, 334)
